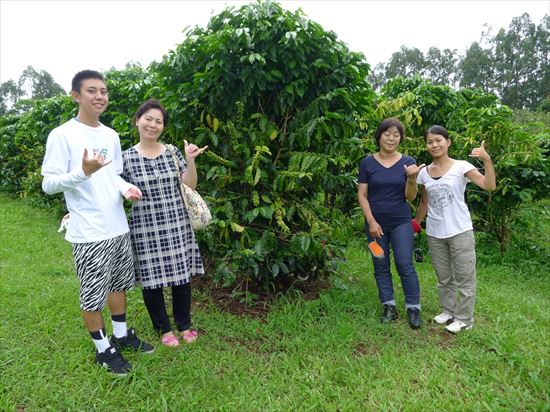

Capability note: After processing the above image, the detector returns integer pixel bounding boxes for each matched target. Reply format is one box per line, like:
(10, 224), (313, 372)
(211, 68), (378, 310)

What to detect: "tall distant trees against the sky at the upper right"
(376, 13), (550, 110)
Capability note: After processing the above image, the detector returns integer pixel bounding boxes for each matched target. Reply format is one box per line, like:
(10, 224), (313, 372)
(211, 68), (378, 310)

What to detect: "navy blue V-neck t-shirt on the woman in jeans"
(359, 155), (416, 227)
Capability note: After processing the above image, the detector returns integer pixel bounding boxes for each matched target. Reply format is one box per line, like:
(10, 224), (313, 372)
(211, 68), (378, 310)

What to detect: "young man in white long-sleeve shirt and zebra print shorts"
(42, 70), (154, 375)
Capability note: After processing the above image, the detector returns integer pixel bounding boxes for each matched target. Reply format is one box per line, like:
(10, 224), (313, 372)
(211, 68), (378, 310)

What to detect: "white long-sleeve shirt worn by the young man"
(42, 119), (131, 243)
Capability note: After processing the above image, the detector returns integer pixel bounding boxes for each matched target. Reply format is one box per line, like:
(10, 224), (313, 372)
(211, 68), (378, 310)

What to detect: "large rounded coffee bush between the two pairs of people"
(153, 2), (373, 286)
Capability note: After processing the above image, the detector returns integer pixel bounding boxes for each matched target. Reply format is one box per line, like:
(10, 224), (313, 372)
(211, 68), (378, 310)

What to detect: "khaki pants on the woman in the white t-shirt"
(428, 230), (476, 325)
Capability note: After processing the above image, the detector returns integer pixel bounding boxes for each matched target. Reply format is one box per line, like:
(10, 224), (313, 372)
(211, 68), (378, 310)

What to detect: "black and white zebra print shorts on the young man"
(73, 233), (135, 312)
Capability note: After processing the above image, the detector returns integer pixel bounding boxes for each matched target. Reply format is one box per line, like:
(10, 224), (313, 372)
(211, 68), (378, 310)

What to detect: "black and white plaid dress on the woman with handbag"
(122, 147), (204, 289)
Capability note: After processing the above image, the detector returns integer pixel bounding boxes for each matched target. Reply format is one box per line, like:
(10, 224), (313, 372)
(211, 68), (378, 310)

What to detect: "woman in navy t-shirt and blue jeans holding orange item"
(357, 119), (424, 329)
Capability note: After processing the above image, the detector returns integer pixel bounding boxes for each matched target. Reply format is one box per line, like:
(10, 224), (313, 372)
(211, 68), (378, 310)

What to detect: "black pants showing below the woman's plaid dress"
(141, 282), (191, 334)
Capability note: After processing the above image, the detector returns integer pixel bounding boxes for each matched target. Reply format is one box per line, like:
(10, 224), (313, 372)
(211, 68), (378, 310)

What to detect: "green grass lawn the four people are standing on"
(0, 196), (550, 411)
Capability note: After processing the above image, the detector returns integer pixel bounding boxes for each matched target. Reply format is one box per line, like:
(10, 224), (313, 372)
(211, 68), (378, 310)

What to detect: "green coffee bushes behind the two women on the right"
(375, 77), (550, 249)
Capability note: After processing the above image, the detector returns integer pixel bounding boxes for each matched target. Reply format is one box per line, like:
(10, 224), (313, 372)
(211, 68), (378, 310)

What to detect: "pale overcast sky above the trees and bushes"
(0, 0), (550, 91)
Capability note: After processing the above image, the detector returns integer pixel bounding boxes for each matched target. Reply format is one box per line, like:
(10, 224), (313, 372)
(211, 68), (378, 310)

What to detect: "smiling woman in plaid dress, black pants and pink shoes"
(122, 99), (207, 346)
